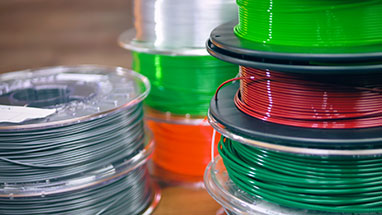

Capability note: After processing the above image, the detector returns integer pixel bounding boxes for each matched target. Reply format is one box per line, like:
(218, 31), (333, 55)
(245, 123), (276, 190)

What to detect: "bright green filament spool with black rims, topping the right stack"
(207, 0), (382, 64)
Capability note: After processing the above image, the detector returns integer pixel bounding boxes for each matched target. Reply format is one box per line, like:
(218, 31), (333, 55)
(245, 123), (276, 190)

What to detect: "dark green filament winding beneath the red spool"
(218, 137), (382, 213)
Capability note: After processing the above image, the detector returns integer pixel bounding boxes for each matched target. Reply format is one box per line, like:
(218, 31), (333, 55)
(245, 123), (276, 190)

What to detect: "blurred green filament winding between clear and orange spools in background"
(133, 52), (238, 116)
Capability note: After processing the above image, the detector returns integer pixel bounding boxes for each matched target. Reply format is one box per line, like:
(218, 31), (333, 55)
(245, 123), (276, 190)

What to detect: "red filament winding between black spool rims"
(235, 66), (382, 129)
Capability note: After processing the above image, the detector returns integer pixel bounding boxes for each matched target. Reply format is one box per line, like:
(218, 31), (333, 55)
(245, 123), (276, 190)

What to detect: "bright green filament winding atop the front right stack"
(234, 0), (382, 47)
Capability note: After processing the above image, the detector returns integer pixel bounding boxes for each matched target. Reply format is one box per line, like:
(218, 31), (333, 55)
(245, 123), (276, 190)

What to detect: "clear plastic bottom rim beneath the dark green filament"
(204, 156), (382, 215)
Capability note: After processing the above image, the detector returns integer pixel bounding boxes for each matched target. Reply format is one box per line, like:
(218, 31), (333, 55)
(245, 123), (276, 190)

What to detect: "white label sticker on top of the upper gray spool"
(0, 105), (56, 123)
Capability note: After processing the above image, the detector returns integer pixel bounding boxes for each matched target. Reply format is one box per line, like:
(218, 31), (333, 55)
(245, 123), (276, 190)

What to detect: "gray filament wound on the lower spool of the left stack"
(0, 166), (157, 215)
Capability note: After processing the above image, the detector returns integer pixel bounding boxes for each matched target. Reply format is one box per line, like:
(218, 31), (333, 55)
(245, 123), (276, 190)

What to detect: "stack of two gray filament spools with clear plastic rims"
(0, 65), (160, 215)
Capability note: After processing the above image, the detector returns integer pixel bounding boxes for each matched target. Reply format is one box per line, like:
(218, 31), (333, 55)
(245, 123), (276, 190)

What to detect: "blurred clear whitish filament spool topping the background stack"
(119, 0), (237, 55)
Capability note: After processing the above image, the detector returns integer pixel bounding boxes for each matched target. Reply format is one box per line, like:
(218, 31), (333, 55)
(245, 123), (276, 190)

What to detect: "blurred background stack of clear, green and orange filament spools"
(119, 0), (237, 182)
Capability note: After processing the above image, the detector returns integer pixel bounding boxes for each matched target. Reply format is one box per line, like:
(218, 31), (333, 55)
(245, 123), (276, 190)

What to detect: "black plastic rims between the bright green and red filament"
(207, 22), (382, 74)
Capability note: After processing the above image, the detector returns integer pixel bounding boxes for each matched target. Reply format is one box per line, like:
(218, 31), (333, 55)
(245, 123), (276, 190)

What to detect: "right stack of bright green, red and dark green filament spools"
(204, 0), (382, 215)
